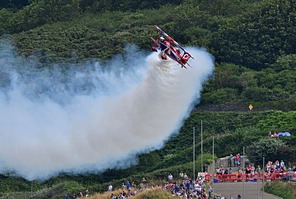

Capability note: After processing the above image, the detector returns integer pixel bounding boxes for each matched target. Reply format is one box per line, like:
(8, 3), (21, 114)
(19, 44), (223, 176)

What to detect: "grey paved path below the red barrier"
(213, 182), (282, 199)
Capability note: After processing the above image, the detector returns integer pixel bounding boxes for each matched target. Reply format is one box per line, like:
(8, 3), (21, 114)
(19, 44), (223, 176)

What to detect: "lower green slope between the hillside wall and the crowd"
(1, 111), (296, 197)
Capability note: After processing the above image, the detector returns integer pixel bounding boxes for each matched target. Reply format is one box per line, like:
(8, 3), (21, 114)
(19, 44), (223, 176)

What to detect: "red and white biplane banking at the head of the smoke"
(150, 25), (193, 68)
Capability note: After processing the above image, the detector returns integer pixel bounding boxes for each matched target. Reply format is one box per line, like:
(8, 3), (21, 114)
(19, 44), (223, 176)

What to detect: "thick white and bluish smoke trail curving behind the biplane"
(0, 42), (214, 180)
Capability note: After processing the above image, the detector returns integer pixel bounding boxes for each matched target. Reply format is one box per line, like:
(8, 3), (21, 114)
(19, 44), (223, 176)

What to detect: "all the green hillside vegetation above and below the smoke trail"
(0, 0), (296, 198)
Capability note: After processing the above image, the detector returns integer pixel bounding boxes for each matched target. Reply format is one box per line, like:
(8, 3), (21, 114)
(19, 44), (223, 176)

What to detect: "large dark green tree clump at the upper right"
(212, 1), (296, 70)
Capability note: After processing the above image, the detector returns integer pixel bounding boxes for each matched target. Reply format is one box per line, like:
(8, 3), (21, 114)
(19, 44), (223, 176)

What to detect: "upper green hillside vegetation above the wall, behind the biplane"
(0, 0), (296, 111)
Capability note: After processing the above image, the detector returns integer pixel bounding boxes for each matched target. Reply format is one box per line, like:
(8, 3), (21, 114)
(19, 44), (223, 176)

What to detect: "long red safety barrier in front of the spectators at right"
(205, 172), (287, 182)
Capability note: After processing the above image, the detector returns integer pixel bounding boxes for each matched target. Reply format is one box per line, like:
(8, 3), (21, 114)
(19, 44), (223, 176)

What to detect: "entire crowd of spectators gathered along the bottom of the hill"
(65, 157), (296, 199)
